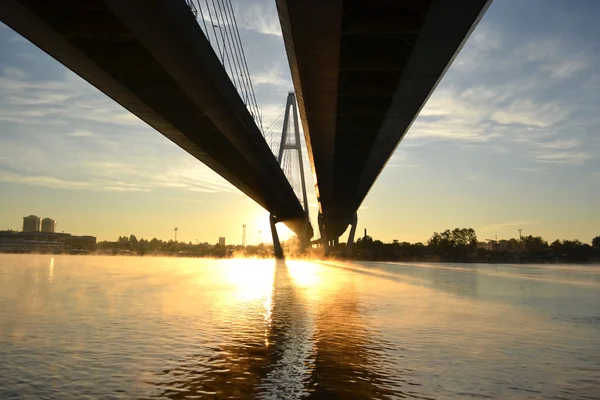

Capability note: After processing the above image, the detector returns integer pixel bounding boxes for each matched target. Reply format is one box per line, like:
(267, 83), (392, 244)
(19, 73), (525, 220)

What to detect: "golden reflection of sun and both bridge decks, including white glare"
(156, 260), (410, 399)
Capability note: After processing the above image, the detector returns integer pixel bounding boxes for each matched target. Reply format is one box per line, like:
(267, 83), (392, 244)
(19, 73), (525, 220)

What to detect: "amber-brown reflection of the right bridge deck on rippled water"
(308, 268), (422, 400)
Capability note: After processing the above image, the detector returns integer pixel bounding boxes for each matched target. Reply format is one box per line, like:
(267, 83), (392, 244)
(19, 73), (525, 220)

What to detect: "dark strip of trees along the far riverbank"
(4, 228), (600, 264)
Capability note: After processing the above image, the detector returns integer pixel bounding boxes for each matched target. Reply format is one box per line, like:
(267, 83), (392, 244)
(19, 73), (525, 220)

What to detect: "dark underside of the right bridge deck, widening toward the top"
(276, 0), (491, 240)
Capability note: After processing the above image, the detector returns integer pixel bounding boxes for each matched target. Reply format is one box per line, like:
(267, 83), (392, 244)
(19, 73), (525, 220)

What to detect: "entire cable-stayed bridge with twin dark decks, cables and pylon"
(0, 0), (491, 255)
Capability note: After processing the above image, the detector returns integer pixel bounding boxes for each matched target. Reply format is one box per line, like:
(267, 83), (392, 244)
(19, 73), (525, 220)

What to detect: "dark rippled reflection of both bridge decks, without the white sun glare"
(149, 261), (419, 399)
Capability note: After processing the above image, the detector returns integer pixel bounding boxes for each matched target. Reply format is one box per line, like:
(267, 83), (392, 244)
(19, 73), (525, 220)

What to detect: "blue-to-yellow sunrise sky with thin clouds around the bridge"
(0, 0), (600, 244)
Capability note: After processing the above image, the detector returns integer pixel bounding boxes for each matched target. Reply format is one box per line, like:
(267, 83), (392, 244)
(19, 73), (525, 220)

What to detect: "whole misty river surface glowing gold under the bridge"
(0, 255), (600, 399)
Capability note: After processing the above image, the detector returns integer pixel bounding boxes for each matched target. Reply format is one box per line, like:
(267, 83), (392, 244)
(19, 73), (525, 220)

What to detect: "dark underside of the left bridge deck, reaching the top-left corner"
(0, 0), (312, 238)
